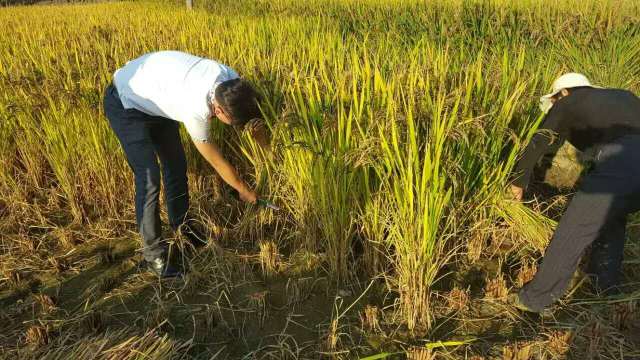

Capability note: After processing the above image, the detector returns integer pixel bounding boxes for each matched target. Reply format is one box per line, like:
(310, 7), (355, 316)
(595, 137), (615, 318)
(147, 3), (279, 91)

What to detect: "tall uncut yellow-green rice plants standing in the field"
(0, 0), (640, 331)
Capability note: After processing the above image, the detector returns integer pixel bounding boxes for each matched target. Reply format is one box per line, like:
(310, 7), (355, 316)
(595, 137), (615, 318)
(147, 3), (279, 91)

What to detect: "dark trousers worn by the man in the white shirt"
(104, 85), (189, 260)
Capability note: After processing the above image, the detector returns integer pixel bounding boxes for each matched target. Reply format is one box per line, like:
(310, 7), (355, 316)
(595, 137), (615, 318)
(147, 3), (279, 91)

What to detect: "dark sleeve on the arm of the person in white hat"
(513, 104), (566, 188)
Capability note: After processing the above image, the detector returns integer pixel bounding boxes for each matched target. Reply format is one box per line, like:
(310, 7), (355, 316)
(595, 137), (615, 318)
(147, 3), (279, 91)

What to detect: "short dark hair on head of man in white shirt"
(215, 79), (261, 126)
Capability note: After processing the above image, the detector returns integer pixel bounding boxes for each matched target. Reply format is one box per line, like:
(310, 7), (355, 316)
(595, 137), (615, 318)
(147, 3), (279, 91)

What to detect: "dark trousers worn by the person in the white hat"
(520, 135), (640, 311)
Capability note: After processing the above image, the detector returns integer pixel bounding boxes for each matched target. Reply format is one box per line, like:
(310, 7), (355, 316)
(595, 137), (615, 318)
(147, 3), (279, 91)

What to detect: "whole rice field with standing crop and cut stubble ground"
(0, 0), (640, 359)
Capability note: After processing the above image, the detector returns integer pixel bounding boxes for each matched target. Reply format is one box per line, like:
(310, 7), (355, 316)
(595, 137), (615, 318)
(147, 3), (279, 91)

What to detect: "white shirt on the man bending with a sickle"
(113, 51), (239, 142)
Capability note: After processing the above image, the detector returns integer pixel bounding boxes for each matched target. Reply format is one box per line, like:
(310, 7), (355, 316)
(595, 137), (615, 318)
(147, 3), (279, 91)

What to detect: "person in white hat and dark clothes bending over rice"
(511, 73), (640, 312)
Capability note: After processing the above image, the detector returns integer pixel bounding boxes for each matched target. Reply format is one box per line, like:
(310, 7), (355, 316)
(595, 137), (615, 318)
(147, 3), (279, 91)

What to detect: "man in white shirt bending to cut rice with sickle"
(104, 51), (261, 277)
